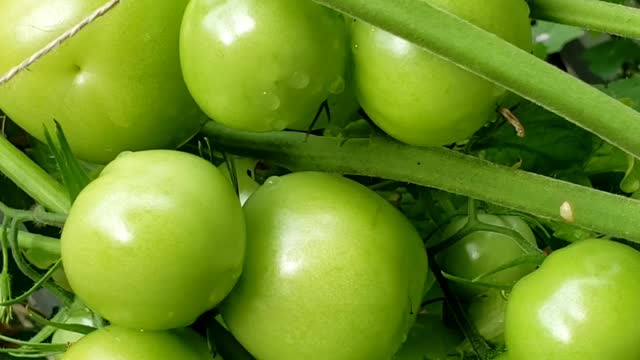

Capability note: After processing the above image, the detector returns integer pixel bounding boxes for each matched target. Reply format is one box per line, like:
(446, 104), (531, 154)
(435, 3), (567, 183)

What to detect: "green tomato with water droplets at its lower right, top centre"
(180, 0), (349, 131)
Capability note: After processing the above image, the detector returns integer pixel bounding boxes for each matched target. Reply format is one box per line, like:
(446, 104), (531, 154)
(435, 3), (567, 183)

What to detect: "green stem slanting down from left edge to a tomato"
(0, 136), (71, 213)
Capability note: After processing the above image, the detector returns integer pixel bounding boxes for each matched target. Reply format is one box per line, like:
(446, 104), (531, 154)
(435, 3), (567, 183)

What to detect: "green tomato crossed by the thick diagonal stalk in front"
(352, 0), (531, 146)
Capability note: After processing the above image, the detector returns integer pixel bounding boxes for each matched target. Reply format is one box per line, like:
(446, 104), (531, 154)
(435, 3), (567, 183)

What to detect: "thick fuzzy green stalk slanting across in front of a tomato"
(314, 0), (640, 158)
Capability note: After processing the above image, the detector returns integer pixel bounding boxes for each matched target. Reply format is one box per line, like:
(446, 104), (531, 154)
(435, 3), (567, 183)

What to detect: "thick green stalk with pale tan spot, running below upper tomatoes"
(202, 122), (640, 242)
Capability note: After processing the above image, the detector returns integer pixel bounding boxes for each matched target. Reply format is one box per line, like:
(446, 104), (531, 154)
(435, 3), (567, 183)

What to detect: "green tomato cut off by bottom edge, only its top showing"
(62, 326), (212, 360)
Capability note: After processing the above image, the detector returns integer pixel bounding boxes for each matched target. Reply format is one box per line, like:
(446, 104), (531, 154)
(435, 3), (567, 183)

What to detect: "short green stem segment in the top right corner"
(529, 0), (640, 39)
